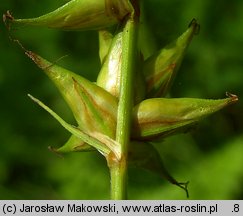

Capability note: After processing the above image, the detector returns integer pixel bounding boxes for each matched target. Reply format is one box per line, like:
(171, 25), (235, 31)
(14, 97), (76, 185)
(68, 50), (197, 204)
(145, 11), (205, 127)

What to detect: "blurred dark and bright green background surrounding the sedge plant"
(0, 0), (243, 199)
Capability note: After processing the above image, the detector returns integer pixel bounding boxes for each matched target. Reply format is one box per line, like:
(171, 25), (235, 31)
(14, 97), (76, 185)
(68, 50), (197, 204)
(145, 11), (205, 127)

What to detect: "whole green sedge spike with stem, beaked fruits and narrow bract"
(3, 0), (238, 199)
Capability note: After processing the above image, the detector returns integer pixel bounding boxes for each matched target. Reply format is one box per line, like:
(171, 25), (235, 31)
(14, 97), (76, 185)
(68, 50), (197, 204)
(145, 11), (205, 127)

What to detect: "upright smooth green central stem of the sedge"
(109, 10), (137, 200)
